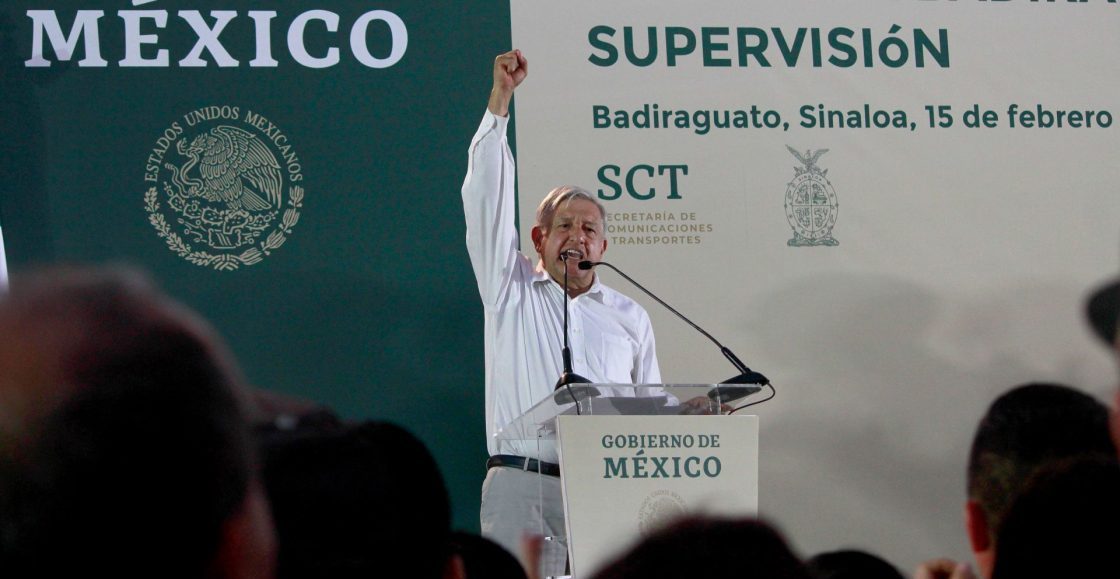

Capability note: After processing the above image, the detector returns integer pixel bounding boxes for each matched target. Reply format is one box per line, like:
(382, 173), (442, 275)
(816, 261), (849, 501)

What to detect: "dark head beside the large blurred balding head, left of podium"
(261, 422), (451, 579)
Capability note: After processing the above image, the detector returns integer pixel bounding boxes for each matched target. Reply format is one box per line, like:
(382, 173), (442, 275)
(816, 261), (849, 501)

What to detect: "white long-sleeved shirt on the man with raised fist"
(463, 110), (661, 461)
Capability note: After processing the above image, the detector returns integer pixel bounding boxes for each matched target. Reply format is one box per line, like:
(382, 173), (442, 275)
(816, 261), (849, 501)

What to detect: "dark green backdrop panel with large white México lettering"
(0, 0), (510, 530)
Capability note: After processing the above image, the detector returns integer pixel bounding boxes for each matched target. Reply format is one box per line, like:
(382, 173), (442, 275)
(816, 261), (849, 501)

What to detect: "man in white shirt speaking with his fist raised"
(463, 50), (661, 569)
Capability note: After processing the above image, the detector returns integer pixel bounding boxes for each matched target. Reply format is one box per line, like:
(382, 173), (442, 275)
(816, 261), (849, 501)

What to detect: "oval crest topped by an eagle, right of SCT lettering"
(785, 144), (840, 246)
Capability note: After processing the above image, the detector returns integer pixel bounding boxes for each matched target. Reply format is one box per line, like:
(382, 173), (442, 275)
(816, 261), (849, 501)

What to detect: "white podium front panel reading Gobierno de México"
(557, 415), (758, 579)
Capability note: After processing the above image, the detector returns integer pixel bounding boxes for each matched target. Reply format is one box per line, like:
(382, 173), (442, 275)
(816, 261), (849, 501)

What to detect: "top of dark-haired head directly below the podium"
(595, 516), (812, 579)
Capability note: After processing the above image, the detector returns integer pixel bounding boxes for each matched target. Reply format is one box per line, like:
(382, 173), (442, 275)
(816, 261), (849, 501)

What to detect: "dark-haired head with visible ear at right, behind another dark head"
(965, 384), (1116, 577)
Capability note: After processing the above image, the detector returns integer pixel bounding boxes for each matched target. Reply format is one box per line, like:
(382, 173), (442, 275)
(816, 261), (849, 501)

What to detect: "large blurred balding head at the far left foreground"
(0, 264), (273, 578)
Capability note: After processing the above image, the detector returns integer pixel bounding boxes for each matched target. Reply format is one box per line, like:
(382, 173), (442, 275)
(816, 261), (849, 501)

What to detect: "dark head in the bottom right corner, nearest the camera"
(992, 457), (1120, 579)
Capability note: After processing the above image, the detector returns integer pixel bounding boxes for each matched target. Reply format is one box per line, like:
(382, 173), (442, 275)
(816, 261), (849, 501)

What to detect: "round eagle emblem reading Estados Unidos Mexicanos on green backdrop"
(143, 105), (304, 271)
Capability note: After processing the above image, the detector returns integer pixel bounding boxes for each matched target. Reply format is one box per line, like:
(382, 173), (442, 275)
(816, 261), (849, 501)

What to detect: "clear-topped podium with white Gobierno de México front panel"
(495, 384), (760, 579)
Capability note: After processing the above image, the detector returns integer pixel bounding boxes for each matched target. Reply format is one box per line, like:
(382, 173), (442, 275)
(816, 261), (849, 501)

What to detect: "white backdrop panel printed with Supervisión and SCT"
(512, 0), (1120, 570)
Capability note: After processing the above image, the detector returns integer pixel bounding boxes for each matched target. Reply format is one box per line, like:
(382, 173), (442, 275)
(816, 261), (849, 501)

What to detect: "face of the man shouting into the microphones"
(533, 198), (607, 295)
